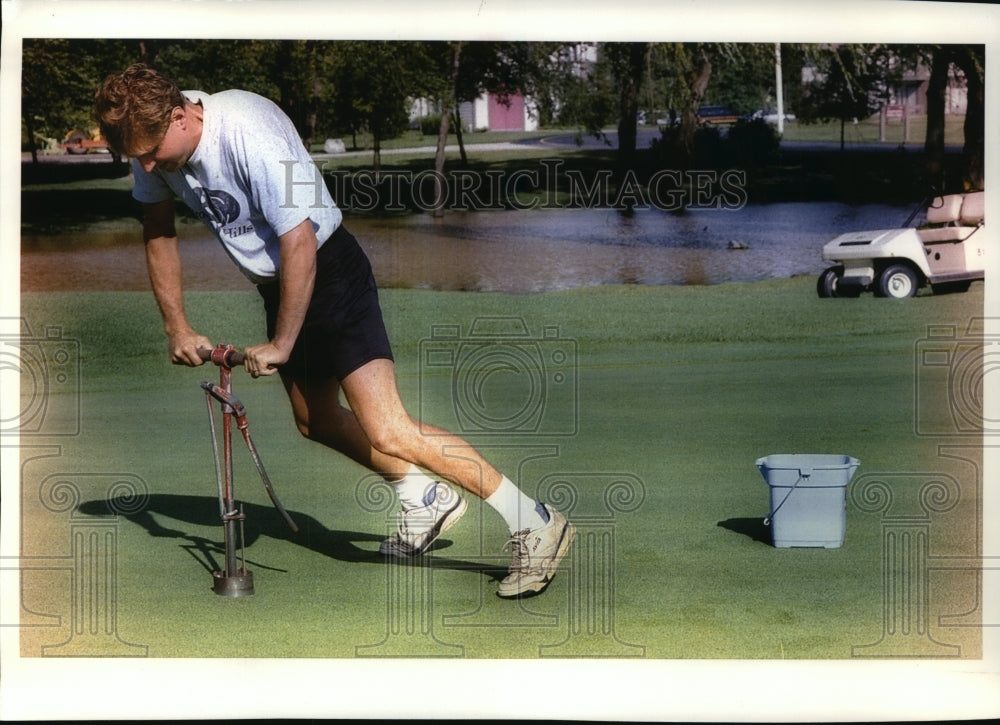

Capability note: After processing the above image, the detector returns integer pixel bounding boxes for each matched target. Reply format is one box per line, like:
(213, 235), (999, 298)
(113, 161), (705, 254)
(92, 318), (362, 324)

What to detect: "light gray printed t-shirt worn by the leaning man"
(132, 90), (342, 284)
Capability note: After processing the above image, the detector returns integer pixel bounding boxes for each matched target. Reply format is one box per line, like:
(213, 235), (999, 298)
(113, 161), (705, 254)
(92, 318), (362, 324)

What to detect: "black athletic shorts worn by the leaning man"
(257, 225), (392, 383)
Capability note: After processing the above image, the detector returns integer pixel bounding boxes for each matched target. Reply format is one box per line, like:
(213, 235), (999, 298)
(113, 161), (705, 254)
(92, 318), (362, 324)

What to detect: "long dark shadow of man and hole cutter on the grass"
(77, 494), (507, 581)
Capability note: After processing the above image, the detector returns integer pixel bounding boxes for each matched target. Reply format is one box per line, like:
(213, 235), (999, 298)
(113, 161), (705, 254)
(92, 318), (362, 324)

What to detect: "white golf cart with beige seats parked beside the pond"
(816, 191), (986, 298)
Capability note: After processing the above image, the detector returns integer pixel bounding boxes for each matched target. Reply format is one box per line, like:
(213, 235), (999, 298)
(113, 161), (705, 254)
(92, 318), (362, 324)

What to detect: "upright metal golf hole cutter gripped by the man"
(199, 345), (299, 597)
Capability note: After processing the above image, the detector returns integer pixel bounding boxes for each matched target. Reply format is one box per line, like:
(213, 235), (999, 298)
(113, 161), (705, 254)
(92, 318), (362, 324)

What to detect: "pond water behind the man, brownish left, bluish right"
(21, 202), (911, 292)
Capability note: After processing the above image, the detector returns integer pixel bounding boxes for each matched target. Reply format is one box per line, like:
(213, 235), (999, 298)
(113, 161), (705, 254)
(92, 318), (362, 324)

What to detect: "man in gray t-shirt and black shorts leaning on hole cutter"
(95, 64), (574, 598)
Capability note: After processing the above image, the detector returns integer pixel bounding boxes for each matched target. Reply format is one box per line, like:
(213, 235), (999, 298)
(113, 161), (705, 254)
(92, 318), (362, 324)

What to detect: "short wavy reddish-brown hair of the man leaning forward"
(94, 63), (185, 156)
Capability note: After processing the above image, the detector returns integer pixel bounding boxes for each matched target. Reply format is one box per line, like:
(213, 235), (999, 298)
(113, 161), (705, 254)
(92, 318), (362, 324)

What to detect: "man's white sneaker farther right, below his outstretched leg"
(497, 504), (576, 599)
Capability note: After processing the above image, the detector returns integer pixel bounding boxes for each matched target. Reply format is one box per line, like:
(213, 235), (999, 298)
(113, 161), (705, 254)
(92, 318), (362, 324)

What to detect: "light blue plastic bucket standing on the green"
(757, 453), (861, 549)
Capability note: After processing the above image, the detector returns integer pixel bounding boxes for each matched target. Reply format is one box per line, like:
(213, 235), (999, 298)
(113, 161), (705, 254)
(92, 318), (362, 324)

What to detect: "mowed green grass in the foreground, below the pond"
(15, 277), (983, 659)
